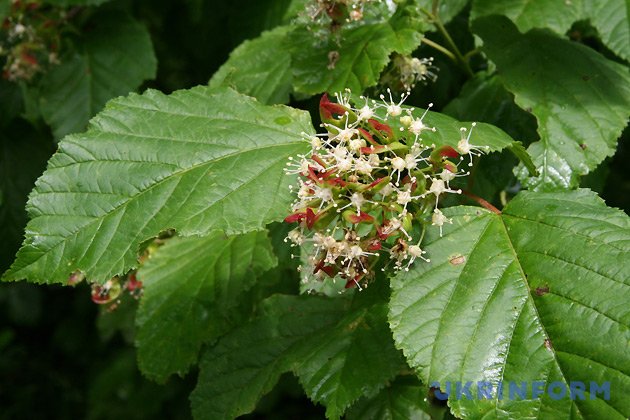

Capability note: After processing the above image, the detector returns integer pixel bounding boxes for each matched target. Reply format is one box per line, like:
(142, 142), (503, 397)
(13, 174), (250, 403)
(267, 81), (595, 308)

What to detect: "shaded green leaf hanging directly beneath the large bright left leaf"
(136, 231), (278, 382)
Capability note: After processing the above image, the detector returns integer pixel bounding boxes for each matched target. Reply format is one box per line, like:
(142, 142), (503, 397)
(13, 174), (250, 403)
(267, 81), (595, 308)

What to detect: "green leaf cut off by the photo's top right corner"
(471, 0), (630, 60)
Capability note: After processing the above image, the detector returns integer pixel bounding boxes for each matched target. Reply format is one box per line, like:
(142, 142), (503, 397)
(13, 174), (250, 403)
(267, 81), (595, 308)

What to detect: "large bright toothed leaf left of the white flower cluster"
(4, 87), (313, 283)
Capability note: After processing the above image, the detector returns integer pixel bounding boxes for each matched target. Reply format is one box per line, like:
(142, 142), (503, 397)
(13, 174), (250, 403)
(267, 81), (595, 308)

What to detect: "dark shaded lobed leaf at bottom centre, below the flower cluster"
(191, 282), (404, 418)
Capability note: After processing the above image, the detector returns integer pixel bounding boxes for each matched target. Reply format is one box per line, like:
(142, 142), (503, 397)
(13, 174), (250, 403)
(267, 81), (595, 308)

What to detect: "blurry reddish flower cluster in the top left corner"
(0, 0), (67, 81)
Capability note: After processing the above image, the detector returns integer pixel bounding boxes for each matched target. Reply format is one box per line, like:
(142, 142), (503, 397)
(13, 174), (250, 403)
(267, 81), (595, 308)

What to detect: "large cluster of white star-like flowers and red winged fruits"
(285, 90), (482, 289)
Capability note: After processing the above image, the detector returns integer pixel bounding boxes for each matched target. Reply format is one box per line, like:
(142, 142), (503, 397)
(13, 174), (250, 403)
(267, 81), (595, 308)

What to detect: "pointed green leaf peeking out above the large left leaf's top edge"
(210, 26), (292, 104)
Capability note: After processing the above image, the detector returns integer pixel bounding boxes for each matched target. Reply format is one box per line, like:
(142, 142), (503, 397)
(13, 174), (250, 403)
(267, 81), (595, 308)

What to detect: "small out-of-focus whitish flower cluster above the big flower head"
(380, 54), (439, 92)
